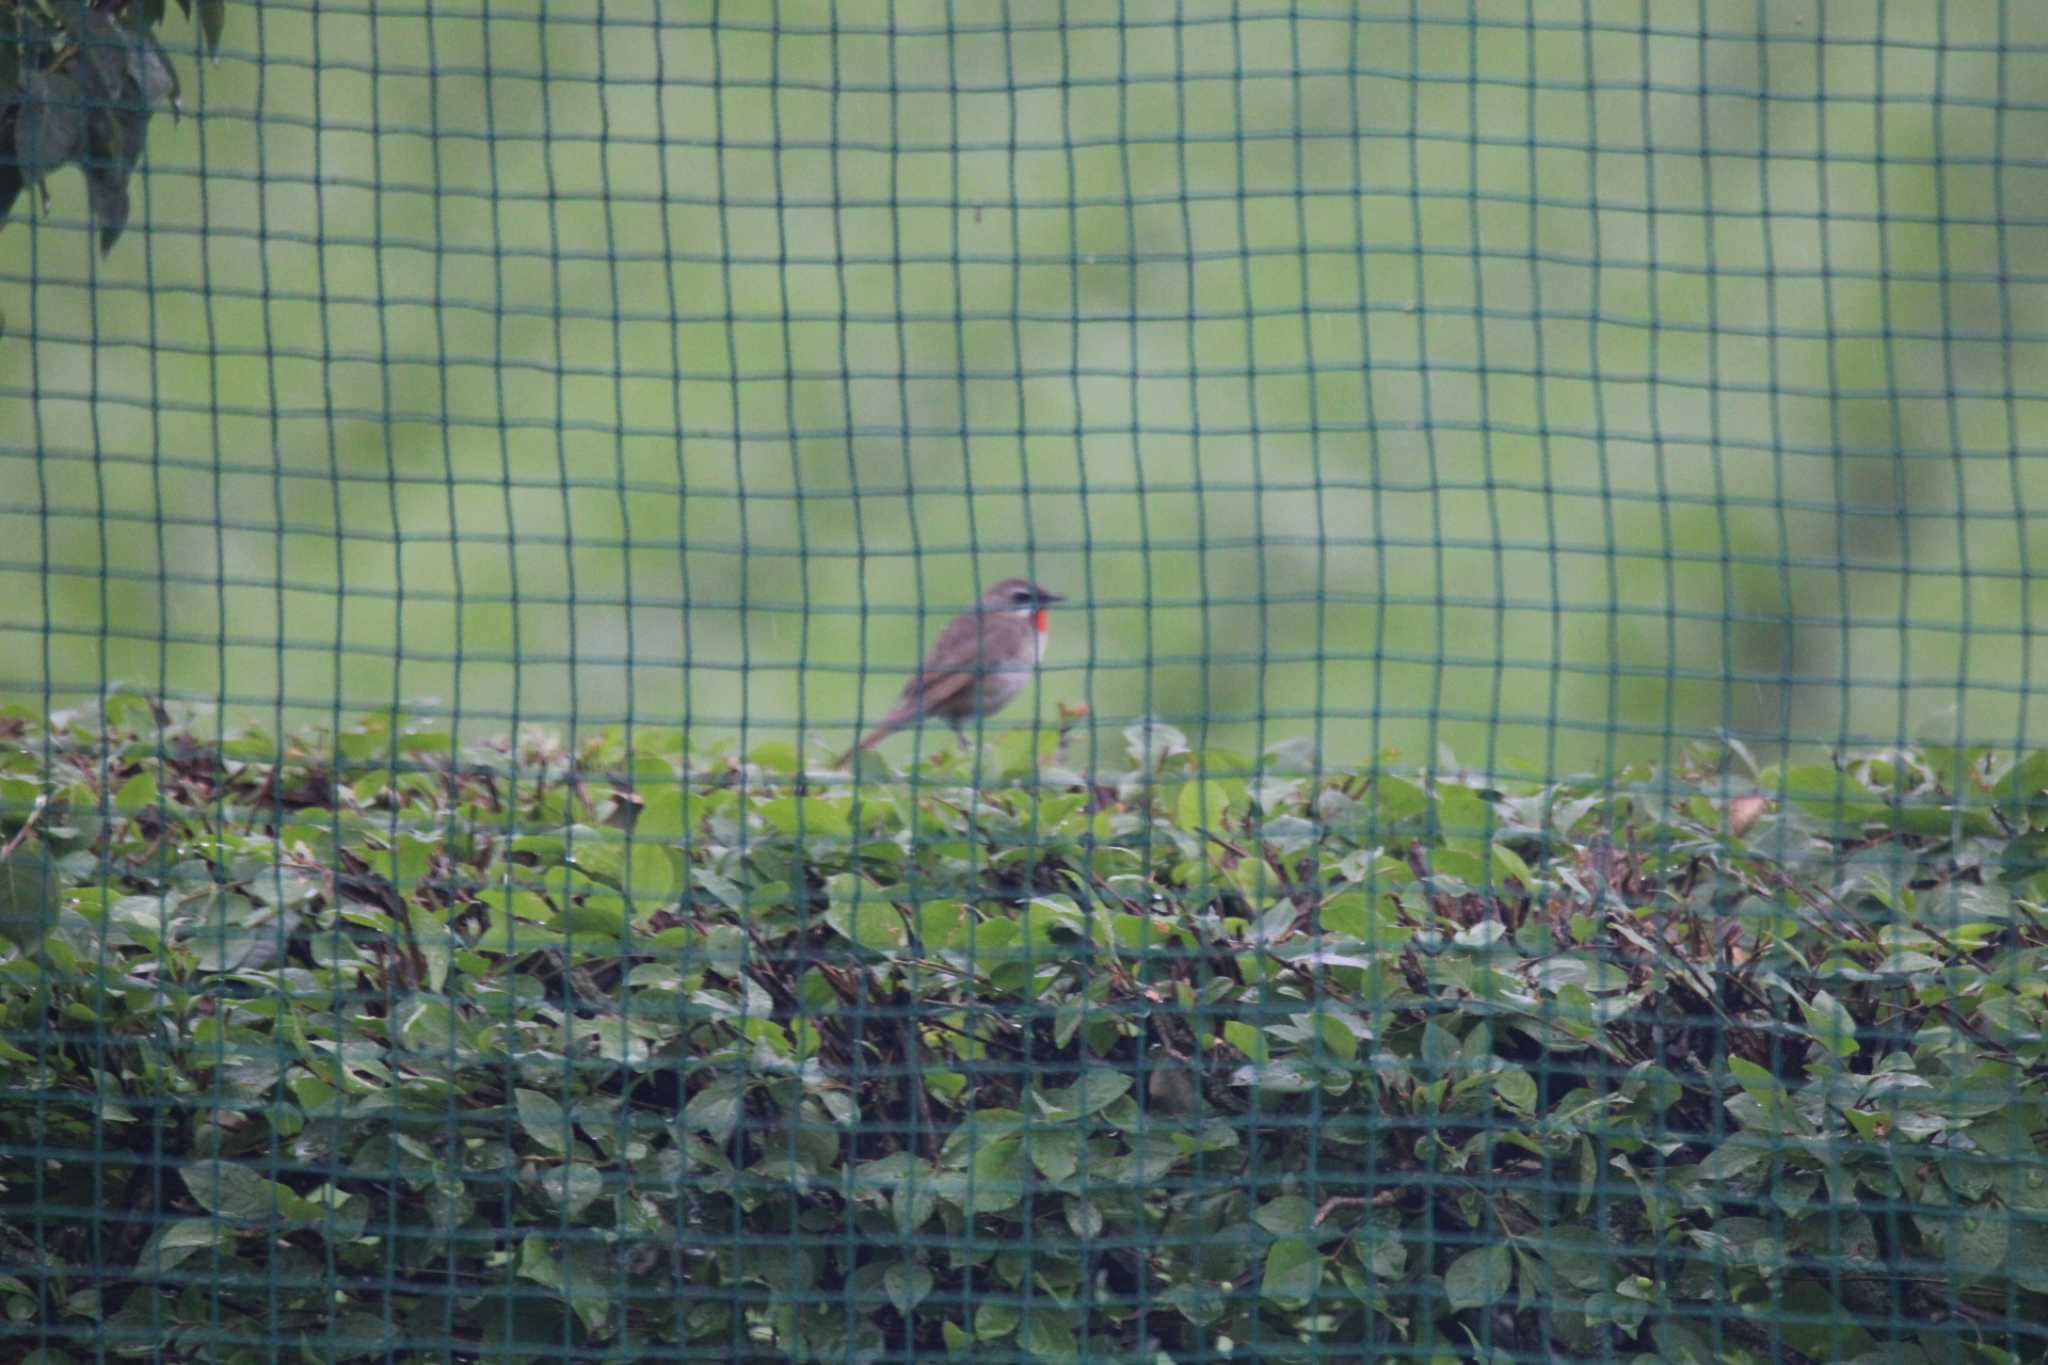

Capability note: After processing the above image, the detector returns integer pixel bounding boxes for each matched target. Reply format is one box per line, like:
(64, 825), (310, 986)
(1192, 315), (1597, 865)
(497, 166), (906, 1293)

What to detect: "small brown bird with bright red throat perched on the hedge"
(838, 579), (1065, 767)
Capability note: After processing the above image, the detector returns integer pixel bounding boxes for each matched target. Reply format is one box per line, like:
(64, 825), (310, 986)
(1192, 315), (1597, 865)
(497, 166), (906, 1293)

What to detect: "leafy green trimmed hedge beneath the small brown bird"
(0, 696), (2048, 1361)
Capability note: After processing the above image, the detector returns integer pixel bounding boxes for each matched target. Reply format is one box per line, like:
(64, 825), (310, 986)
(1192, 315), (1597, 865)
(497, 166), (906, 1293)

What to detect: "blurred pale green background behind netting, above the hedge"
(0, 0), (2048, 774)
